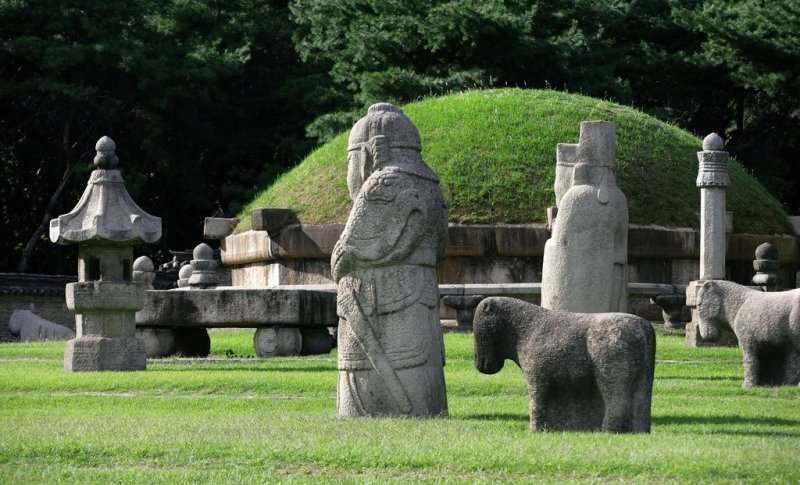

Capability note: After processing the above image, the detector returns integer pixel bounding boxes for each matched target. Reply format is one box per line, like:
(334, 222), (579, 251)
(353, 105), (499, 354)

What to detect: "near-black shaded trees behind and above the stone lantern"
(0, 0), (319, 272)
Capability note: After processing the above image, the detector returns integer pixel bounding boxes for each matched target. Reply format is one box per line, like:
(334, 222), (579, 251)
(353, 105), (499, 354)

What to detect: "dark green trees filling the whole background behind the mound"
(0, 0), (800, 273)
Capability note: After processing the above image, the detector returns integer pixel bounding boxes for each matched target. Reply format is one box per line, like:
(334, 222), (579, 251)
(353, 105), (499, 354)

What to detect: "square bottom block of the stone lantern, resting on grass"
(64, 335), (147, 372)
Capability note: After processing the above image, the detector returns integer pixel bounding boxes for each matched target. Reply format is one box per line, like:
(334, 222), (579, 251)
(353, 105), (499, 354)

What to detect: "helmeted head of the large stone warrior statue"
(347, 103), (432, 199)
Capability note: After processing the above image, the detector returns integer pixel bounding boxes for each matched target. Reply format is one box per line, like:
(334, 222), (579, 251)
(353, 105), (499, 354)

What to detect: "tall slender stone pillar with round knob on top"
(686, 133), (736, 347)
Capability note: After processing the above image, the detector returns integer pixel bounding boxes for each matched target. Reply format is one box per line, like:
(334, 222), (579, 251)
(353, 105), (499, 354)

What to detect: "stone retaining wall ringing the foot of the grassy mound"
(221, 224), (798, 318)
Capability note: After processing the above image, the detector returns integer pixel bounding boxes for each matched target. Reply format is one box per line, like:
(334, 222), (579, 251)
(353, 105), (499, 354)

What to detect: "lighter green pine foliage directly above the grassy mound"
(291, 0), (800, 211)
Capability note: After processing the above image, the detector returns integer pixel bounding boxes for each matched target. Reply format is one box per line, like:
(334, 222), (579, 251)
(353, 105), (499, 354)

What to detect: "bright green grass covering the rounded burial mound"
(236, 89), (793, 234)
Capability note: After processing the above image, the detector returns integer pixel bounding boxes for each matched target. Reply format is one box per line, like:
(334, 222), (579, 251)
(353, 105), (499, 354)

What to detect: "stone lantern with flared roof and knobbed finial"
(50, 136), (161, 371)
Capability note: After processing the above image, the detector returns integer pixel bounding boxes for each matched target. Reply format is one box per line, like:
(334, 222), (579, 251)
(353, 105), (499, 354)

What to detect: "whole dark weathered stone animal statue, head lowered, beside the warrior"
(474, 297), (656, 433)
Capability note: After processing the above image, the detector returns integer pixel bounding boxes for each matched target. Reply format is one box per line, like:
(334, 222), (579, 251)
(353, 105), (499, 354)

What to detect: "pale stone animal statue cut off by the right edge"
(697, 280), (800, 387)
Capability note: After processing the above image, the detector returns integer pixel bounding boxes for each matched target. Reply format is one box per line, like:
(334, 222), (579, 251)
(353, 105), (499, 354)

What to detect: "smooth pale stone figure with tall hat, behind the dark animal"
(542, 122), (628, 313)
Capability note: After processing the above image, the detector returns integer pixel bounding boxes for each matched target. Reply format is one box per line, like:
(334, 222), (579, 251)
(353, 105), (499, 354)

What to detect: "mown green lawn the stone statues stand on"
(0, 330), (800, 483)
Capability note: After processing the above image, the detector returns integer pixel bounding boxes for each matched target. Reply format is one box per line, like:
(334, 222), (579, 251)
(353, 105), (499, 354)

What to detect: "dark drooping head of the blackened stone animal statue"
(472, 298), (506, 374)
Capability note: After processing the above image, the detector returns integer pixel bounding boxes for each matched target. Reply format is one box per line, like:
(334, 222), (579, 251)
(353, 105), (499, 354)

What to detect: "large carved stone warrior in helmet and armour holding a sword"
(331, 103), (447, 417)
